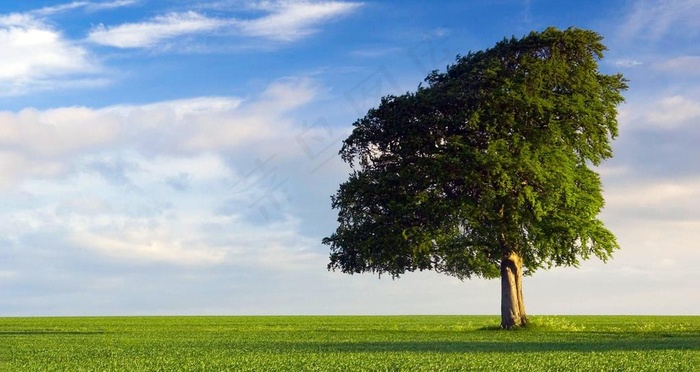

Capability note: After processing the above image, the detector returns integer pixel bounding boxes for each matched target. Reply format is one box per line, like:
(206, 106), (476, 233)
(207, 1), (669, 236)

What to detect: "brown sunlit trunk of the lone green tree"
(501, 252), (527, 329)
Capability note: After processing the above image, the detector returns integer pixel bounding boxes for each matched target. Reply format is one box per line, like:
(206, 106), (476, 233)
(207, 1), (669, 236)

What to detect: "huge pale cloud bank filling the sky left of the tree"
(0, 78), (328, 270)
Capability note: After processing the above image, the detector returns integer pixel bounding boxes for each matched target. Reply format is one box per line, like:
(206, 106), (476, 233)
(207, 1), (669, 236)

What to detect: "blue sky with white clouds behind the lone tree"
(0, 0), (700, 316)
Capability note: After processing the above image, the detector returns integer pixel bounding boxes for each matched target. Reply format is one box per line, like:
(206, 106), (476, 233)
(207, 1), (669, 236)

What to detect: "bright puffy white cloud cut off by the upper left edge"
(0, 14), (100, 94)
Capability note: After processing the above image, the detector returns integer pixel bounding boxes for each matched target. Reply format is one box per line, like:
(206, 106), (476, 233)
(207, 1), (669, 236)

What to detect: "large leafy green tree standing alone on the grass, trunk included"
(323, 28), (627, 329)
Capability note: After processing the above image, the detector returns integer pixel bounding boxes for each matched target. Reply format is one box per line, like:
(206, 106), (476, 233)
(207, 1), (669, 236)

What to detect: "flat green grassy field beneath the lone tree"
(0, 316), (700, 371)
